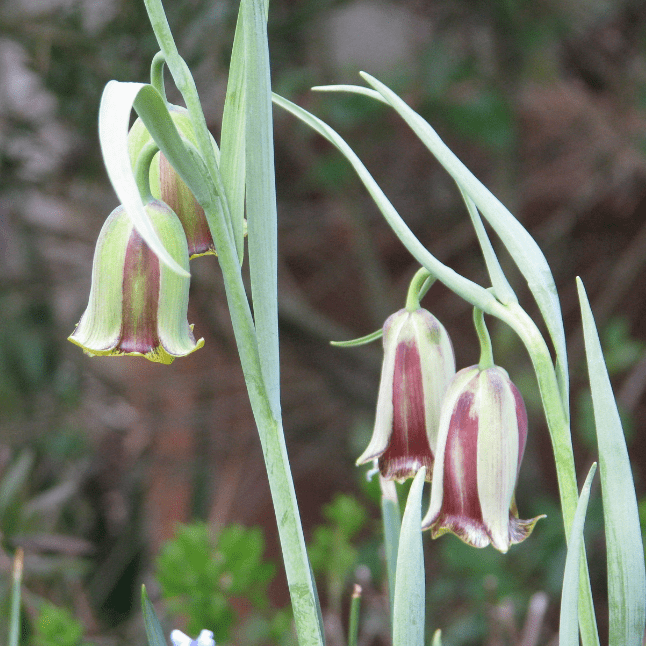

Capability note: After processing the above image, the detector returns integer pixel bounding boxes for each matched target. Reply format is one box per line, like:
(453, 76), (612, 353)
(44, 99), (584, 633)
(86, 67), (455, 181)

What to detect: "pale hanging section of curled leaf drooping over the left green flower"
(99, 81), (189, 276)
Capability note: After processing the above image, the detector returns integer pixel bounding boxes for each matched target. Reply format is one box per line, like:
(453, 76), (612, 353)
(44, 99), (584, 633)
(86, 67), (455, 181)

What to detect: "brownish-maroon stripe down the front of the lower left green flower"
(116, 228), (159, 354)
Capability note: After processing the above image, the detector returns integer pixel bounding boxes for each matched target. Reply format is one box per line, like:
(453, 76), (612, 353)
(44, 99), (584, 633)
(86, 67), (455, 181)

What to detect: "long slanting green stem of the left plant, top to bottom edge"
(145, 0), (323, 646)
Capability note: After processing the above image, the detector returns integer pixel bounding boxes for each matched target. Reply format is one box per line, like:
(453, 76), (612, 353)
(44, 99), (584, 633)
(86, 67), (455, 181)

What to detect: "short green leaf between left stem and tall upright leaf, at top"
(220, 4), (246, 263)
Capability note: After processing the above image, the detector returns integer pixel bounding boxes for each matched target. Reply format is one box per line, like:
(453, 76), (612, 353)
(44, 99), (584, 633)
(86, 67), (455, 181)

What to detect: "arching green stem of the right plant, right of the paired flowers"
(491, 303), (599, 646)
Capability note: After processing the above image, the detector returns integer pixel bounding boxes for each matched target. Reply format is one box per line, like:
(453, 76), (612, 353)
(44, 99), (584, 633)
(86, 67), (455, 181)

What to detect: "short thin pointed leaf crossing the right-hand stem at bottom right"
(559, 462), (597, 646)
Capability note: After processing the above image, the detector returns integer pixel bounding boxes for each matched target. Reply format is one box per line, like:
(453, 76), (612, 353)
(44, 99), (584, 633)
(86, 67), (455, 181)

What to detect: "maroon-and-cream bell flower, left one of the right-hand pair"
(357, 309), (455, 480)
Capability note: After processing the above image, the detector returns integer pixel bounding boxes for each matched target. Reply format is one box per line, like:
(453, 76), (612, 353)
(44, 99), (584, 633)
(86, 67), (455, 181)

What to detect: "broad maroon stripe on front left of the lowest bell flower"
(442, 391), (482, 523)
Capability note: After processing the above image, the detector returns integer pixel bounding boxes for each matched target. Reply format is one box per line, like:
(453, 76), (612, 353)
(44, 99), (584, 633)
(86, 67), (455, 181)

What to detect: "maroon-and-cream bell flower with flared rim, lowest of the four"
(422, 365), (542, 552)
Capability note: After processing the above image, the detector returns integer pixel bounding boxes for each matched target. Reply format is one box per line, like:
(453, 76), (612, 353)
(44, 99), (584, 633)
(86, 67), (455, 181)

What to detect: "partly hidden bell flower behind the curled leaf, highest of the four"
(128, 105), (219, 258)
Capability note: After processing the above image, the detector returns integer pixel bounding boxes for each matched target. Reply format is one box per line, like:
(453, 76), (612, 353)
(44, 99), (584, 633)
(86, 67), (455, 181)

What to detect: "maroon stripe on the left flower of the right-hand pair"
(379, 341), (433, 480)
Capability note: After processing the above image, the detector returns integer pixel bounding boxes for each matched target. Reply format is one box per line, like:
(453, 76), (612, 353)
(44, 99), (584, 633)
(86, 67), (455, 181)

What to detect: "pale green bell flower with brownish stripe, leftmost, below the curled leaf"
(69, 200), (204, 363)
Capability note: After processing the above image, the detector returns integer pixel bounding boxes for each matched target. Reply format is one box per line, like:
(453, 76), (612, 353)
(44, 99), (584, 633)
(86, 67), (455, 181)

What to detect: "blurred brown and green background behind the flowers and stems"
(0, 0), (646, 646)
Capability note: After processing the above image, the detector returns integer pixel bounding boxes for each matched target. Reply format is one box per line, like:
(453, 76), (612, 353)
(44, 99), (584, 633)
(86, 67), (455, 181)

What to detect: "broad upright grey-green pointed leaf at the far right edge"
(577, 279), (646, 646)
